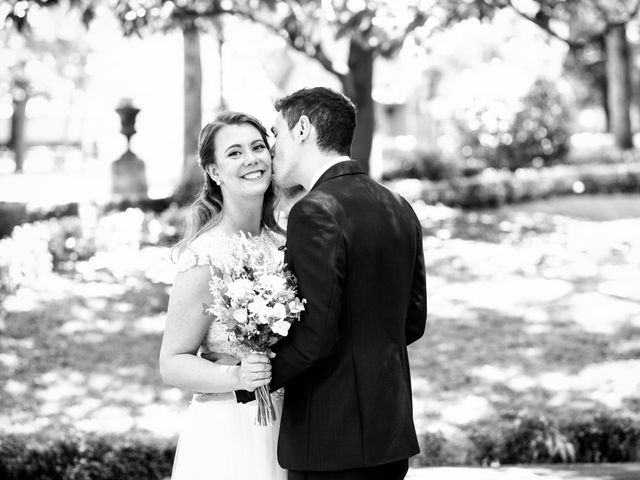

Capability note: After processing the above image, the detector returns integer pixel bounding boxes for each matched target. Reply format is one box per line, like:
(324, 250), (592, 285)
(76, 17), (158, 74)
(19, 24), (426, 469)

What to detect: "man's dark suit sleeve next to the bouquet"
(270, 199), (346, 390)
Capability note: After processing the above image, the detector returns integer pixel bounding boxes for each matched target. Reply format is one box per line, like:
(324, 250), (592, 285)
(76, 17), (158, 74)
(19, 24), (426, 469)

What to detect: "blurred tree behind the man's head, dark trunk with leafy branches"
(242, 0), (434, 171)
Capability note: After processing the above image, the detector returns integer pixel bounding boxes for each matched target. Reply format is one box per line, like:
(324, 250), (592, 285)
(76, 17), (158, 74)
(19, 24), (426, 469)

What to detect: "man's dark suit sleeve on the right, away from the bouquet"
(405, 218), (427, 345)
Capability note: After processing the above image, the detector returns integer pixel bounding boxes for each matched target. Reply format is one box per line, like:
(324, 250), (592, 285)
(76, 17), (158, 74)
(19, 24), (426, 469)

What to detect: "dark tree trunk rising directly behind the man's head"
(342, 40), (375, 172)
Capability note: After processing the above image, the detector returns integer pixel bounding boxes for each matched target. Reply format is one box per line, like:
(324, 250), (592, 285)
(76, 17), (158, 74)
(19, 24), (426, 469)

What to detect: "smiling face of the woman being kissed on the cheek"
(210, 123), (271, 200)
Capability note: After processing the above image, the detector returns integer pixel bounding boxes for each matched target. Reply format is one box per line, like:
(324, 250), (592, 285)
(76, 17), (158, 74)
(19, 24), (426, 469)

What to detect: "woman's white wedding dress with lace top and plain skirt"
(171, 231), (287, 480)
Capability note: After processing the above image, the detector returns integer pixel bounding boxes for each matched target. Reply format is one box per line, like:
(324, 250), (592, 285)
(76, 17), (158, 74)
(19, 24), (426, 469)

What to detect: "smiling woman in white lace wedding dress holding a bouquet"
(160, 112), (286, 480)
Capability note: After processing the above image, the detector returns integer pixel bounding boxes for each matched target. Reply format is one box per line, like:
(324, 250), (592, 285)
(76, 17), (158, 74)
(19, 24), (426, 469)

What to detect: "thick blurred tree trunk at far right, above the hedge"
(605, 24), (633, 150)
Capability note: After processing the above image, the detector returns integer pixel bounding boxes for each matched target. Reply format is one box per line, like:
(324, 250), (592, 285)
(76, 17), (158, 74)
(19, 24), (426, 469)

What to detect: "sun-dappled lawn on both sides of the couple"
(0, 196), (640, 446)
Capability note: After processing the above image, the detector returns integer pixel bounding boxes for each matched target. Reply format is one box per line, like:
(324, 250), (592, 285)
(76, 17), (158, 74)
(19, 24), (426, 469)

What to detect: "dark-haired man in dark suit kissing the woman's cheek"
(239, 88), (426, 480)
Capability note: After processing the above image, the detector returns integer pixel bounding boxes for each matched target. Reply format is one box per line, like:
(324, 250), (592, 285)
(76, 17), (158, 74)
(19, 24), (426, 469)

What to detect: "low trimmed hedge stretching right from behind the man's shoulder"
(389, 162), (640, 209)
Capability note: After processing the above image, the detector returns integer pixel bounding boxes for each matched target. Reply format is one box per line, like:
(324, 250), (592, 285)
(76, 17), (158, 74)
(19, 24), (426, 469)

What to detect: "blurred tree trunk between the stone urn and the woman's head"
(175, 23), (202, 204)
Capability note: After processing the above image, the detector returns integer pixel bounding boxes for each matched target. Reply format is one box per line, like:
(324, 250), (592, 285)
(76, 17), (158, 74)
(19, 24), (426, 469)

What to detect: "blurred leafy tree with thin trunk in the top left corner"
(0, 1), (88, 172)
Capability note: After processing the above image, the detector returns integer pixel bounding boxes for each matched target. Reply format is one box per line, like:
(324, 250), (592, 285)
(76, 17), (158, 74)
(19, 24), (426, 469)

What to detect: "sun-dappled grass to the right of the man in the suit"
(410, 196), (640, 438)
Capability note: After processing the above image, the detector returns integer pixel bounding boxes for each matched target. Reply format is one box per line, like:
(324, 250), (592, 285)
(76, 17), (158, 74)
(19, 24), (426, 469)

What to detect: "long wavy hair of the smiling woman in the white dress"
(176, 111), (283, 253)
